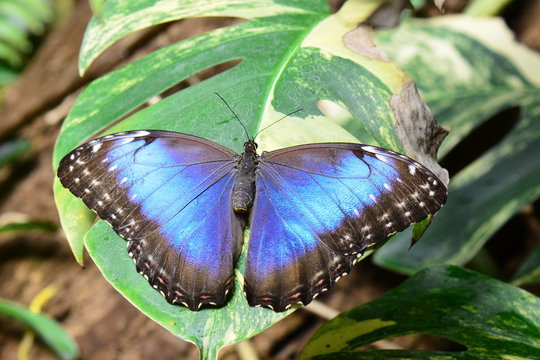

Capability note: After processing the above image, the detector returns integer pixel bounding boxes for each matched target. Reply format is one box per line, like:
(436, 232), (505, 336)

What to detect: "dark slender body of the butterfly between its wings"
(232, 140), (259, 213)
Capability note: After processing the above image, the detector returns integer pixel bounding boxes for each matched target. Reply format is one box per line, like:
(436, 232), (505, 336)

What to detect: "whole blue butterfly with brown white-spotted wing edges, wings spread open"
(58, 130), (447, 312)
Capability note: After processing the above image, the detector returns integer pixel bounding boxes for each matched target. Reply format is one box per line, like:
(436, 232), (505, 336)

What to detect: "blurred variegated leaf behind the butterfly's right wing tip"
(374, 16), (540, 274)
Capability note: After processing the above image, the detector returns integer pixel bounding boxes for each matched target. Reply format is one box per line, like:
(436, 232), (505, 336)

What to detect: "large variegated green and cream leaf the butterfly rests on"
(53, 0), (445, 358)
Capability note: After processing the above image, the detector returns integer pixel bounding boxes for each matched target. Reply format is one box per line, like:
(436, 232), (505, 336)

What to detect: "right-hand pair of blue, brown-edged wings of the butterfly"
(244, 144), (446, 311)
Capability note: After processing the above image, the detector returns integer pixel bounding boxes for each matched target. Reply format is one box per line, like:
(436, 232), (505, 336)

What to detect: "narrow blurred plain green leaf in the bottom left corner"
(0, 299), (79, 360)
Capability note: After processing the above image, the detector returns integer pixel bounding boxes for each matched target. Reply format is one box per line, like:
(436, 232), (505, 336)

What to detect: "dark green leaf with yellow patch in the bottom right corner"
(300, 266), (540, 360)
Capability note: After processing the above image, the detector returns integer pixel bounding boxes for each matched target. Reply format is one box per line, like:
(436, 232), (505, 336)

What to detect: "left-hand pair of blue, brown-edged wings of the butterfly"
(58, 131), (244, 310)
